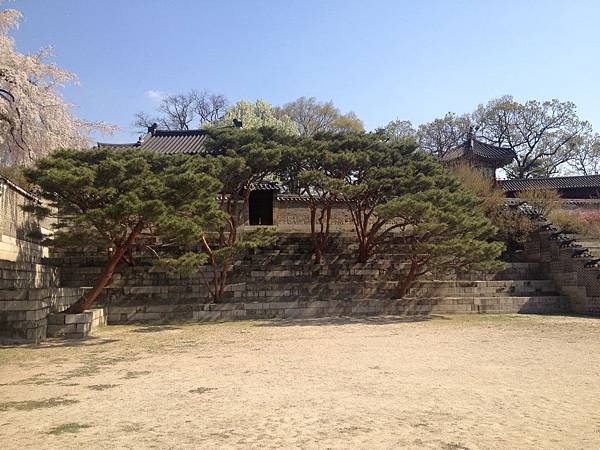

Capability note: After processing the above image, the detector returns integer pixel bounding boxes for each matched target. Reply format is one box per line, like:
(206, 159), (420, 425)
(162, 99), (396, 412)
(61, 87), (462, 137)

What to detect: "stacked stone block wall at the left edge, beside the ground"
(0, 288), (84, 342)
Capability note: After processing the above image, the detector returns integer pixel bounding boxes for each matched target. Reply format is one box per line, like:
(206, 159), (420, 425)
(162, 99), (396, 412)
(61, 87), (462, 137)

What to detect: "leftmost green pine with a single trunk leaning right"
(25, 148), (220, 312)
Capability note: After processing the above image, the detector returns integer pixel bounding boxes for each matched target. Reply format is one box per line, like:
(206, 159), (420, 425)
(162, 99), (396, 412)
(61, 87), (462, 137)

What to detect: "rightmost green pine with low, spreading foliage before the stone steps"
(376, 183), (504, 296)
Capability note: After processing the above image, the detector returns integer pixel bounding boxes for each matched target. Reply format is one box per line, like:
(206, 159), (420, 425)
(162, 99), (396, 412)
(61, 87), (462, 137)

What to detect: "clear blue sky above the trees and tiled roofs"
(5, 0), (600, 142)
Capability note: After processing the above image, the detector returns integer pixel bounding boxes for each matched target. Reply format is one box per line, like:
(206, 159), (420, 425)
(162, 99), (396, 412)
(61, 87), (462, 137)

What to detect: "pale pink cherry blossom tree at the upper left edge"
(0, 0), (114, 165)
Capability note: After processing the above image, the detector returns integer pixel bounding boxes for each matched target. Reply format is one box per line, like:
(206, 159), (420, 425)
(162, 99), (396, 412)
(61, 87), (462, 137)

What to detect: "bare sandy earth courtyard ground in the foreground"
(0, 315), (600, 449)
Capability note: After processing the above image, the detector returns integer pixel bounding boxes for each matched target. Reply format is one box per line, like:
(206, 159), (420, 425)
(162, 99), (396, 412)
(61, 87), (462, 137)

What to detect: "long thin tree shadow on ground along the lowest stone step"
(256, 315), (450, 327)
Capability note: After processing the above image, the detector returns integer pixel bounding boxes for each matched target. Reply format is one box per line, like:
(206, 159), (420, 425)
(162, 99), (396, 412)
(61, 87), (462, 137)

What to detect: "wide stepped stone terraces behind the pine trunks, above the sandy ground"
(52, 233), (569, 323)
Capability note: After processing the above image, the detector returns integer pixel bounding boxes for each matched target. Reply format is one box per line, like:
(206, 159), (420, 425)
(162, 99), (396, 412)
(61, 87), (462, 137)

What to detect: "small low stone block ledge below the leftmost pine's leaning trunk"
(47, 308), (106, 339)
